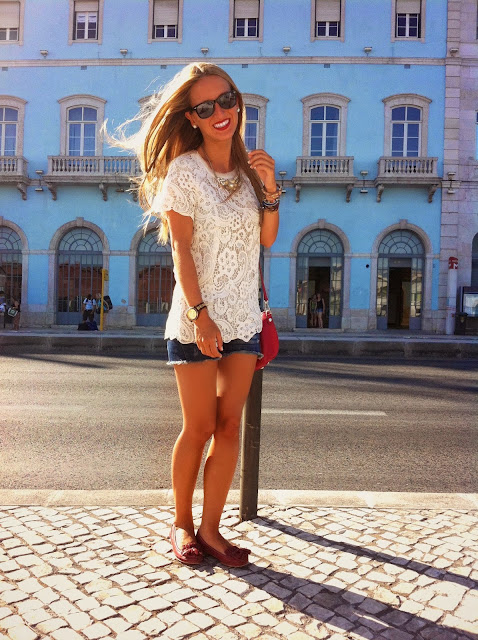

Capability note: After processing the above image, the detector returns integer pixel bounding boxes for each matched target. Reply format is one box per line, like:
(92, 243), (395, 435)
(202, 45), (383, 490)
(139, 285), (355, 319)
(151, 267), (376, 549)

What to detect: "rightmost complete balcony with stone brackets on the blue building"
(375, 156), (440, 202)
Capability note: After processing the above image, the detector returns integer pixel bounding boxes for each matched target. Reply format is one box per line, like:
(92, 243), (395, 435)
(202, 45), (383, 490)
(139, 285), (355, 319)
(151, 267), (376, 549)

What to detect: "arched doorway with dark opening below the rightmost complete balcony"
(377, 229), (425, 331)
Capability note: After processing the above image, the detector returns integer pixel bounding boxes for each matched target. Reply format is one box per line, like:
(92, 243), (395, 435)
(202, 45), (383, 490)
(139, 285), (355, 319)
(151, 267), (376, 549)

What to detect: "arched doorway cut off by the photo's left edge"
(0, 227), (22, 304)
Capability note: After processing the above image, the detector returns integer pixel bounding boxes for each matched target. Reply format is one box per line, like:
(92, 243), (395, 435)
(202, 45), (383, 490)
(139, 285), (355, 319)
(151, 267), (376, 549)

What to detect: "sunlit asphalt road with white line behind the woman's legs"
(0, 354), (478, 492)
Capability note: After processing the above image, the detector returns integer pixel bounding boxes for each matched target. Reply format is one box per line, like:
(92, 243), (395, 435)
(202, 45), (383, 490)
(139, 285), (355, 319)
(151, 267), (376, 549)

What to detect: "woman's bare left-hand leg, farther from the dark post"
(171, 361), (217, 547)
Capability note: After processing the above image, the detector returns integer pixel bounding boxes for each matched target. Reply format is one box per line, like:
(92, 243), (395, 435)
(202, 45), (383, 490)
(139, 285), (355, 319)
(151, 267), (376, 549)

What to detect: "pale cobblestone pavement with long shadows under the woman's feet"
(0, 506), (478, 640)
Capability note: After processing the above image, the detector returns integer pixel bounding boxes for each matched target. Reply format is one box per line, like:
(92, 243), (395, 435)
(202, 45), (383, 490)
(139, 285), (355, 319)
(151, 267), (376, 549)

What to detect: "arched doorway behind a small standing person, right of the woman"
(296, 229), (344, 329)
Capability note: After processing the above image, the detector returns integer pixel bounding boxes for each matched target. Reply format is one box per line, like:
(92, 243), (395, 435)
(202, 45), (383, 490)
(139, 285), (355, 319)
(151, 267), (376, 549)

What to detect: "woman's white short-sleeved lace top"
(153, 151), (262, 343)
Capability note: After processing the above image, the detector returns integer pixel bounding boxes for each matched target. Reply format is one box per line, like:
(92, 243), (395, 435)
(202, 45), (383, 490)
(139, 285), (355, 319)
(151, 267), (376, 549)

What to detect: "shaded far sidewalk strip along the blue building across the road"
(0, 326), (478, 358)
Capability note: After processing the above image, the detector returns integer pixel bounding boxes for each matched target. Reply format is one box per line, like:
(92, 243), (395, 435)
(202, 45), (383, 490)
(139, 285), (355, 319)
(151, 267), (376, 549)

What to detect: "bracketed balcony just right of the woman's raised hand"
(292, 156), (356, 202)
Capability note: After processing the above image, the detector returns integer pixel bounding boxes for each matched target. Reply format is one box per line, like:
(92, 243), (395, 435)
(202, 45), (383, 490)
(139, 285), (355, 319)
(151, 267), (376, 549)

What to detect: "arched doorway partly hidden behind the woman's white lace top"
(136, 230), (174, 326)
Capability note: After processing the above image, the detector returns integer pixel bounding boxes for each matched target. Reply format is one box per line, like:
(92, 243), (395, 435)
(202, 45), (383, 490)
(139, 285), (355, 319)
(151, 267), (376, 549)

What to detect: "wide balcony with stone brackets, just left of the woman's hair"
(44, 156), (140, 200)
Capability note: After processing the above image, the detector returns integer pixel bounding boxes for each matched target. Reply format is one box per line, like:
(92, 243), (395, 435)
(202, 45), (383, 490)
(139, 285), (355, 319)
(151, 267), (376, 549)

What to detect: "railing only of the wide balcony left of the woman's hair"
(48, 156), (140, 178)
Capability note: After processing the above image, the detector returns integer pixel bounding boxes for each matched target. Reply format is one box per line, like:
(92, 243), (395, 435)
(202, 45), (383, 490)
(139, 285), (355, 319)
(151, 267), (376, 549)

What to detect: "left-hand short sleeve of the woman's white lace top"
(151, 156), (196, 220)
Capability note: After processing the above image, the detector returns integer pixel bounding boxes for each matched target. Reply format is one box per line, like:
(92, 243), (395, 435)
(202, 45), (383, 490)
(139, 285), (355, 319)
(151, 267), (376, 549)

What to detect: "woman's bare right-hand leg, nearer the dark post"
(201, 353), (256, 553)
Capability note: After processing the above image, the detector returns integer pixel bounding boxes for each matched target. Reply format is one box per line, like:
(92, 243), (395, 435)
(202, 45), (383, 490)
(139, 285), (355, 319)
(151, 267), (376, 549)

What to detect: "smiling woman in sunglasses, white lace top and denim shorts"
(123, 63), (280, 567)
